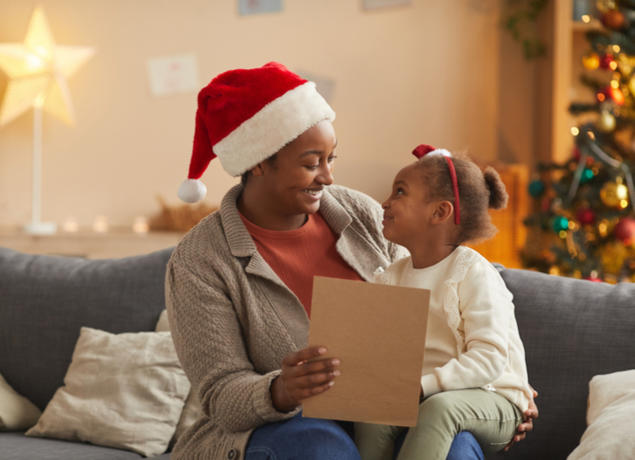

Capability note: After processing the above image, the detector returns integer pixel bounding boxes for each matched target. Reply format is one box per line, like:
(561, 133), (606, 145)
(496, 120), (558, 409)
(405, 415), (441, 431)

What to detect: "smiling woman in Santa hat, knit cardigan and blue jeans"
(166, 63), (531, 460)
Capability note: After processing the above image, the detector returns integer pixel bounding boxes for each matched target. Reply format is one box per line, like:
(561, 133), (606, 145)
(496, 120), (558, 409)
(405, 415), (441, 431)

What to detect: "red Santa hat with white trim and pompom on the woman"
(178, 62), (335, 203)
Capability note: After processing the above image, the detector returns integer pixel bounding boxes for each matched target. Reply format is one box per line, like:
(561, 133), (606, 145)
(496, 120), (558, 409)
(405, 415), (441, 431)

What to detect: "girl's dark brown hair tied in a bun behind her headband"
(418, 154), (508, 244)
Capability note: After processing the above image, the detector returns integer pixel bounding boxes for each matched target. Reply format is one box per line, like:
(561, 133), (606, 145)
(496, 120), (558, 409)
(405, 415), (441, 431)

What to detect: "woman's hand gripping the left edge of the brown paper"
(271, 346), (340, 412)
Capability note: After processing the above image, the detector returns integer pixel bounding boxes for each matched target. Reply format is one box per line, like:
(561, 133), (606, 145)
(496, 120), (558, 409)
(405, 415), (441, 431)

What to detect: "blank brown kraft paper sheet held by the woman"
(302, 276), (430, 426)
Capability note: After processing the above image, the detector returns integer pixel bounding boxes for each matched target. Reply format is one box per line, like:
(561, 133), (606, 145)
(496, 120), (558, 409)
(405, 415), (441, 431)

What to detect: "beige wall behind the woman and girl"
(0, 0), (533, 225)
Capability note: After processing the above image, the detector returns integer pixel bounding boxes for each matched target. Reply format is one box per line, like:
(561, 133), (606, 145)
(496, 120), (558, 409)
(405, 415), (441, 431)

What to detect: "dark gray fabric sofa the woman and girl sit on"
(0, 248), (635, 460)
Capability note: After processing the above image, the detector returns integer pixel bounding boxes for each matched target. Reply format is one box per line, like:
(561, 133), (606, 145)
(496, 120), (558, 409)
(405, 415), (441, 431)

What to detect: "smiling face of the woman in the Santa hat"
(261, 120), (337, 216)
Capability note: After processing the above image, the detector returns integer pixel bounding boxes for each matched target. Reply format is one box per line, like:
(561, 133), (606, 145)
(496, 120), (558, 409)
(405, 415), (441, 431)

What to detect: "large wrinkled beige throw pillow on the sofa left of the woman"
(26, 327), (189, 456)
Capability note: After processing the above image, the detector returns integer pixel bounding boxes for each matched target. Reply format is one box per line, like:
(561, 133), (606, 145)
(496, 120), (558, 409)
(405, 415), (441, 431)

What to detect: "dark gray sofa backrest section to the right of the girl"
(501, 269), (635, 459)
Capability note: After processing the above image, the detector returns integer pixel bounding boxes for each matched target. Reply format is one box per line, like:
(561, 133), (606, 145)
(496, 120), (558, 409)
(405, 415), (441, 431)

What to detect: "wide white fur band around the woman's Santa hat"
(213, 81), (335, 176)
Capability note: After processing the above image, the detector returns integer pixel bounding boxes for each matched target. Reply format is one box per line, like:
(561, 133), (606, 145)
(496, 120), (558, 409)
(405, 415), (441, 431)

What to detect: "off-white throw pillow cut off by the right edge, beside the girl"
(567, 370), (635, 460)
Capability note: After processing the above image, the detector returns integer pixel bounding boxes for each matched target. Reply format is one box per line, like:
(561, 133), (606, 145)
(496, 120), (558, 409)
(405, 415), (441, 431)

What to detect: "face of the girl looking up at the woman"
(382, 163), (438, 249)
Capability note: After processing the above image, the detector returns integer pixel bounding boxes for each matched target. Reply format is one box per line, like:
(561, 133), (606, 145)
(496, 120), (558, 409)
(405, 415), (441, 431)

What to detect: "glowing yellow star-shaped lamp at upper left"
(0, 7), (93, 126)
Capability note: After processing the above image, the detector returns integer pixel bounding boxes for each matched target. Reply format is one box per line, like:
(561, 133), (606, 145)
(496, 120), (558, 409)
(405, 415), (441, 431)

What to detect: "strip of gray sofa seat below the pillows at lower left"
(0, 432), (170, 460)
